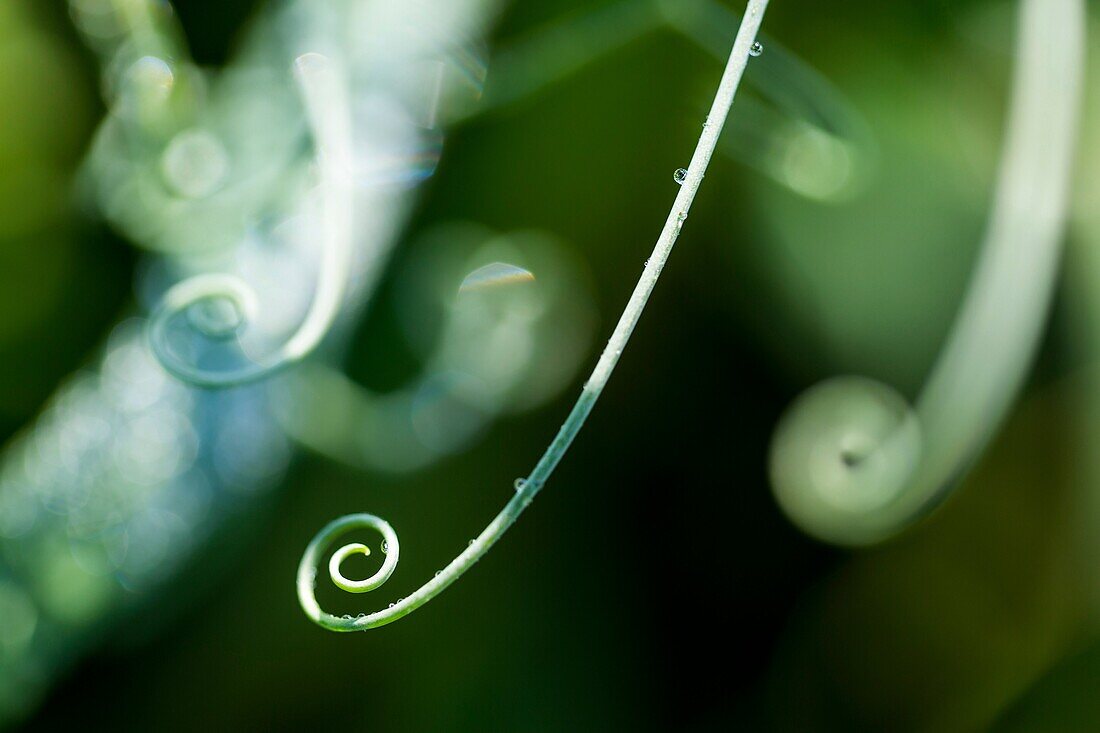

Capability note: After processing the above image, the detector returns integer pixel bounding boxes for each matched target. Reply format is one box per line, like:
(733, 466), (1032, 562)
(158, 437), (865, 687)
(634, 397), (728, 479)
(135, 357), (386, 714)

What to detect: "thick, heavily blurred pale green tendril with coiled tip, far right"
(770, 0), (1085, 545)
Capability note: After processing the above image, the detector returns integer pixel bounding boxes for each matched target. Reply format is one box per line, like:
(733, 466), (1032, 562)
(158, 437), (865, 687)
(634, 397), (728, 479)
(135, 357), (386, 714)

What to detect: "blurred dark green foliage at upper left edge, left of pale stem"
(0, 1), (131, 436)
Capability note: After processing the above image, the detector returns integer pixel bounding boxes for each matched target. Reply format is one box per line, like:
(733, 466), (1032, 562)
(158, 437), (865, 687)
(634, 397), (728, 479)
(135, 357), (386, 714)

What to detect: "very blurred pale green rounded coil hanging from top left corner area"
(69, 0), (301, 258)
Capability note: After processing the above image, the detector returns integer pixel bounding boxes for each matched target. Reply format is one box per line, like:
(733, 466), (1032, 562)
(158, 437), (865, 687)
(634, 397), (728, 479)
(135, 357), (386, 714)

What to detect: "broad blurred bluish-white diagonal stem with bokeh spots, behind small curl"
(0, 0), (498, 713)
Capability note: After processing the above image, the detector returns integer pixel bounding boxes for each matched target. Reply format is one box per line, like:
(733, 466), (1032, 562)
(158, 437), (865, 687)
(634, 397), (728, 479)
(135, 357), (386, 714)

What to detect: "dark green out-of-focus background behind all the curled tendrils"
(0, 0), (1100, 731)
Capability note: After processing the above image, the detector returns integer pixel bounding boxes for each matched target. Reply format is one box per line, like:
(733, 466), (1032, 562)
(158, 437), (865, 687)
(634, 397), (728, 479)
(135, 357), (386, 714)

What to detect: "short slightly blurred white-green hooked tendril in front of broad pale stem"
(149, 53), (352, 387)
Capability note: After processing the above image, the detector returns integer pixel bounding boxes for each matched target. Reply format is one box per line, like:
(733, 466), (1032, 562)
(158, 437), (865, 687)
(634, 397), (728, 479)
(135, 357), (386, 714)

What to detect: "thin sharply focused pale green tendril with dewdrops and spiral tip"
(297, 0), (768, 632)
